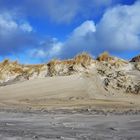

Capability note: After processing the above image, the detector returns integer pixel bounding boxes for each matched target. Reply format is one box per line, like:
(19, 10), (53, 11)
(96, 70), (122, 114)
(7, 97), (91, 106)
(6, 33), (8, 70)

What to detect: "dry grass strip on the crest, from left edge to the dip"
(0, 53), (93, 79)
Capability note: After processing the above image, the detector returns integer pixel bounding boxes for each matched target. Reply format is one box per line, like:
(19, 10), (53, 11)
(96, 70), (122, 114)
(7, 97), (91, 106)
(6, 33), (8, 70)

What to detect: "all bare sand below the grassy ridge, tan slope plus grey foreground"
(0, 75), (140, 140)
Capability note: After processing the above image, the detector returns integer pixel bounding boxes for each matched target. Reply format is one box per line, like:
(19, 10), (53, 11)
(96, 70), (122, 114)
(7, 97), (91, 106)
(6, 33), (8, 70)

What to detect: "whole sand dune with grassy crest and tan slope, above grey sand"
(0, 53), (140, 110)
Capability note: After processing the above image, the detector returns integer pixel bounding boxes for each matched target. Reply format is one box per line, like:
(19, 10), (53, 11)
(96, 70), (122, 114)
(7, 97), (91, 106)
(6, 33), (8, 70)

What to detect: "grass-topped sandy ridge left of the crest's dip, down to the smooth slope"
(0, 53), (94, 85)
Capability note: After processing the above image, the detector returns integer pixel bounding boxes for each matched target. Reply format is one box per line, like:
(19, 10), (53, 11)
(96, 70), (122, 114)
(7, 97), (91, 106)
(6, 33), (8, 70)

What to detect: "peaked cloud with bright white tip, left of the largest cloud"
(59, 20), (96, 59)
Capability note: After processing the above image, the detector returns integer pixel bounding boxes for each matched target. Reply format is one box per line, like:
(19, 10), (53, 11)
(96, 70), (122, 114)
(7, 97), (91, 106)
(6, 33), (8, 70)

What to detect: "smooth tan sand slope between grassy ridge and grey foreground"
(0, 74), (140, 109)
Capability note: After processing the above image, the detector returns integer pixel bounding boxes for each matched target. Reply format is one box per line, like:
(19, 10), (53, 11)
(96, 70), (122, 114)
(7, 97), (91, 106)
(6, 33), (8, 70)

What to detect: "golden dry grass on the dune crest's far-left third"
(0, 59), (46, 80)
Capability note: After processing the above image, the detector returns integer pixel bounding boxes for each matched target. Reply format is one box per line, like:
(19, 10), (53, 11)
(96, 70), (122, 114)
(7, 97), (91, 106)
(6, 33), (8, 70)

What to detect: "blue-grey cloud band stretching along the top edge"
(0, 0), (115, 23)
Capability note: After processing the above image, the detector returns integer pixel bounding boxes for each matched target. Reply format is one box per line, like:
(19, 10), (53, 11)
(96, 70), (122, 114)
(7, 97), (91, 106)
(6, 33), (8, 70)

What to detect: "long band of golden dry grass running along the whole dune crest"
(0, 52), (129, 82)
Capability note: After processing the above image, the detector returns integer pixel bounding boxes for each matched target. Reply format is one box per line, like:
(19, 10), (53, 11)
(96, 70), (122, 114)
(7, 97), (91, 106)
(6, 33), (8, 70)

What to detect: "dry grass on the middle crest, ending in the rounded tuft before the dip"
(47, 53), (93, 76)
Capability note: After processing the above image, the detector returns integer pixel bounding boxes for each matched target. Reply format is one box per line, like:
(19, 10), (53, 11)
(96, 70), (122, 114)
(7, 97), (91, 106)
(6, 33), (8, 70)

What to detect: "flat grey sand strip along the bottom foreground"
(0, 112), (140, 140)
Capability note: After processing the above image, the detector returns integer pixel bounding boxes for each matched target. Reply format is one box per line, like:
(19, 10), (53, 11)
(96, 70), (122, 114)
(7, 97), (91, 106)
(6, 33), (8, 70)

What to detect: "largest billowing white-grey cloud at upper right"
(96, 2), (140, 51)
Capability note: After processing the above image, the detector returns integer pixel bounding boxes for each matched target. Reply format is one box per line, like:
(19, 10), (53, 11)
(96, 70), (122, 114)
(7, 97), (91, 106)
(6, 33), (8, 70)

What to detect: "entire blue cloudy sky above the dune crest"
(0, 0), (140, 64)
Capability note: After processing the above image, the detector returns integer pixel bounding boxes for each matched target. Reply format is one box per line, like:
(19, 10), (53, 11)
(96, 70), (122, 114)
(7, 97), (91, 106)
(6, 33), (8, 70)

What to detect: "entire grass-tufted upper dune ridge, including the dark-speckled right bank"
(0, 52), (140, 94)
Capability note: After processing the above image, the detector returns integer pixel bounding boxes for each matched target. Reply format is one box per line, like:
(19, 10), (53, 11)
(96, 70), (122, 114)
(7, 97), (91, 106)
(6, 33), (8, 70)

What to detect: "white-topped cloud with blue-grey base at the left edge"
(0, 13), (36, 56)
